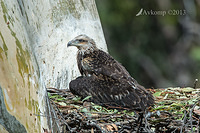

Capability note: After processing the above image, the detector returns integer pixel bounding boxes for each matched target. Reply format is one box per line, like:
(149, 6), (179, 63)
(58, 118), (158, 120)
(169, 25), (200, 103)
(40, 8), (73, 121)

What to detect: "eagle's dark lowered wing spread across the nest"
(69, 75), (154, 111)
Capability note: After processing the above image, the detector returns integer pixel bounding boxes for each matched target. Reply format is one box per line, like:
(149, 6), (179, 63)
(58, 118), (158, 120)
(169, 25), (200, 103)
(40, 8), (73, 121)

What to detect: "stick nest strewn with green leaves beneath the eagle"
(47, 88), (200, 133)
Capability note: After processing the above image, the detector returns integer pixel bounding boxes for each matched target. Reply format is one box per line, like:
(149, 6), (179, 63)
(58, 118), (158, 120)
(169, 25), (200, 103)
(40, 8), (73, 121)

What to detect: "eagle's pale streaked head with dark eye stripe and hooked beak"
(67, 35), (96, 51)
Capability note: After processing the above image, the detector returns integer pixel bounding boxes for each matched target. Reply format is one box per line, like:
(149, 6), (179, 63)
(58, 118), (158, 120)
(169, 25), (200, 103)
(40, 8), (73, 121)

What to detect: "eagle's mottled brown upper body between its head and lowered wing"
(78, 50), (136, 82)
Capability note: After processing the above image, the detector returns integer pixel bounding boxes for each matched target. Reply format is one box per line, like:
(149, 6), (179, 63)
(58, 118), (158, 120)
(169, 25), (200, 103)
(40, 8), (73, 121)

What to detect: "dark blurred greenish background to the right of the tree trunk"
(96, 0), (200, 88)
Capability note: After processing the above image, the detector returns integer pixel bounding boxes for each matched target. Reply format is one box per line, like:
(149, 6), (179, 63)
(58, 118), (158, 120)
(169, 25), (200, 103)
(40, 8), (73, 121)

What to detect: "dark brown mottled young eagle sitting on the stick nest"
(68, 35), (154, 112)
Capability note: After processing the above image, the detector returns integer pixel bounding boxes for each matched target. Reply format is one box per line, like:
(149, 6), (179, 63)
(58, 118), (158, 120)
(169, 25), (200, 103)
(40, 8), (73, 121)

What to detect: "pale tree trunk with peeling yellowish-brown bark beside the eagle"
(0, 0), (106, 133)
